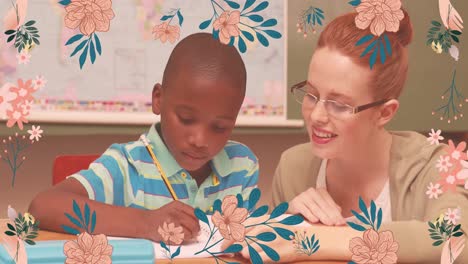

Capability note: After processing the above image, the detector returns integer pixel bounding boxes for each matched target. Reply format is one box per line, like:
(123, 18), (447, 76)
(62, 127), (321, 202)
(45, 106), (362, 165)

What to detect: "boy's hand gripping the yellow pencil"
(144, 201), (200, 241)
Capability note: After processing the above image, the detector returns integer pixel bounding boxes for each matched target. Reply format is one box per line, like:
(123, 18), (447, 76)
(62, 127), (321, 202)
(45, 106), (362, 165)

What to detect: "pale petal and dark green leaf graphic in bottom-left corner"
(0, 206), (39, 263)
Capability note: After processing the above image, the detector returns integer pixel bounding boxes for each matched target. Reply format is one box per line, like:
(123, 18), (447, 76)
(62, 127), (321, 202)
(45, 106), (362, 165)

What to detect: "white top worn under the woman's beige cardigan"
(316, 159), (392, 223)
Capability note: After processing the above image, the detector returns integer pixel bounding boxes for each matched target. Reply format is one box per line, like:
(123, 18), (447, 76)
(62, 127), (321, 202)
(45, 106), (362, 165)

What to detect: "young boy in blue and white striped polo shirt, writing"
(29, 33), (258, 241)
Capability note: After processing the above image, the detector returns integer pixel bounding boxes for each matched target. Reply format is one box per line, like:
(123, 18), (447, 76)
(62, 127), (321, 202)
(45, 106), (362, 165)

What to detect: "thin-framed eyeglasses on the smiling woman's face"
(291, 81), (389, 118)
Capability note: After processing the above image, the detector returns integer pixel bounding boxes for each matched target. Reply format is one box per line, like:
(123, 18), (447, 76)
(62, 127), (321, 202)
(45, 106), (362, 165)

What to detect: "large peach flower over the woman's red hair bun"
(355, 0), (405, 36)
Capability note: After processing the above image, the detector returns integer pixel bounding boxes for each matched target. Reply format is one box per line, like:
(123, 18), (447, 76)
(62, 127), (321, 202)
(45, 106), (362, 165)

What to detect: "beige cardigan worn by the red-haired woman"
(272, 132), (468, 264)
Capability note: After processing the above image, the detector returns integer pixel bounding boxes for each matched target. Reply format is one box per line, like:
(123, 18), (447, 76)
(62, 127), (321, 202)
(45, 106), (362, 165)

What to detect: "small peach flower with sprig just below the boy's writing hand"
(158, 222), (184, 261)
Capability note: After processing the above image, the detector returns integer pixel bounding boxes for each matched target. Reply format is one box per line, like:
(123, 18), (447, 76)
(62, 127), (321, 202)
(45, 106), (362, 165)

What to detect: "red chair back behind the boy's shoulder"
(52, 154), (100, 185)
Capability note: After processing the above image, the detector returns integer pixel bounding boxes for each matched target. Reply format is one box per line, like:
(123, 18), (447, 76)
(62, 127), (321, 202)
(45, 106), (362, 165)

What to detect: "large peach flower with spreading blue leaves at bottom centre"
(195, 188), (304, 263)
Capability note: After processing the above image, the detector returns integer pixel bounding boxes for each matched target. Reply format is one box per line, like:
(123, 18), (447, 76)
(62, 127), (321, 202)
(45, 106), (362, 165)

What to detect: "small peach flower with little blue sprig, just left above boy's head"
(153, 8), (184, 44)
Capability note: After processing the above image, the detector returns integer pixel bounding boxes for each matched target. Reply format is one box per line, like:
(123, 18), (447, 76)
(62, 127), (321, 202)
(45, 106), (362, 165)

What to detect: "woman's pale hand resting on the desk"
(288, 187), (346, 226)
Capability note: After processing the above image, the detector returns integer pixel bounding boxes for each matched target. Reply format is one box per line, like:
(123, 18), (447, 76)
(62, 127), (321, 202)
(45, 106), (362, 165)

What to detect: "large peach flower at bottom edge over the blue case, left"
(63, 233), (113, 264)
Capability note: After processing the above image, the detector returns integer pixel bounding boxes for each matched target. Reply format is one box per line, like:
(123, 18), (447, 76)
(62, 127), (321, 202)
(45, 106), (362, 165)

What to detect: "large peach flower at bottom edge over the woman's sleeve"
(349, 229), (398, 264)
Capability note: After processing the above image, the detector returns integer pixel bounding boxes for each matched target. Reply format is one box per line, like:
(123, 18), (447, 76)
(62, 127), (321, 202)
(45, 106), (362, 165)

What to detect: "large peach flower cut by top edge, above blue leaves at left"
(65, 0), (115, 36)
